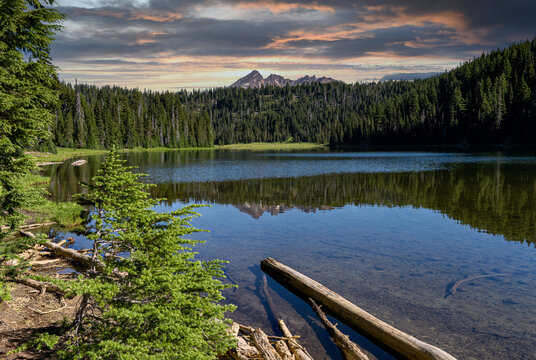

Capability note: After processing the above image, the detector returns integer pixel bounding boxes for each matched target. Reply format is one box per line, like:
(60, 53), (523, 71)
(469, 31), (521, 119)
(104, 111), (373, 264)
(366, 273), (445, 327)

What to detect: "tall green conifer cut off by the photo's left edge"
(0, 0), (63, 233)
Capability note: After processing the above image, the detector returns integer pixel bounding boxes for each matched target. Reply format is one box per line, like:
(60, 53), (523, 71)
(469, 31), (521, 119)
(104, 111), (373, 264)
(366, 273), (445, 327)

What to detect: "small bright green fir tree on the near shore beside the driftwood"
(60, 151), (233, 359)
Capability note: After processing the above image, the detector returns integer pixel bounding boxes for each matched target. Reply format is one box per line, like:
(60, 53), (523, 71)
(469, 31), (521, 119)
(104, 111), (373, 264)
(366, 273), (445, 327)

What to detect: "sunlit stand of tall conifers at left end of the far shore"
(51, 83), (214, 149)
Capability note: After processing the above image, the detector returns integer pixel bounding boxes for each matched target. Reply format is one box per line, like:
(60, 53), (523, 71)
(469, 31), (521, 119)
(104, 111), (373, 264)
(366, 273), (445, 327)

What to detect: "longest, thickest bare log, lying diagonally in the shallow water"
(261, 258), (455, 360)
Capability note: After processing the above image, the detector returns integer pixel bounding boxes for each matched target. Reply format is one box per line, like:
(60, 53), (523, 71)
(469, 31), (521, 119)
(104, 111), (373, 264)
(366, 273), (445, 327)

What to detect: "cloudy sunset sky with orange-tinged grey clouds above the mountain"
(51, 0), (536, 91)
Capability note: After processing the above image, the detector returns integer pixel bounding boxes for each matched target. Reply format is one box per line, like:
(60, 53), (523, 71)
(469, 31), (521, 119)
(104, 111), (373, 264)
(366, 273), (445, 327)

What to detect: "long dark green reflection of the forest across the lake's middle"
(152, 164), (536, 243)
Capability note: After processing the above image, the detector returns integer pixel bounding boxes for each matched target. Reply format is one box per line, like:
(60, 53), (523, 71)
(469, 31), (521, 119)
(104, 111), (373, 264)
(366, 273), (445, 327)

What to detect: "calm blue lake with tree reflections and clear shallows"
(46, 151), (536, 359)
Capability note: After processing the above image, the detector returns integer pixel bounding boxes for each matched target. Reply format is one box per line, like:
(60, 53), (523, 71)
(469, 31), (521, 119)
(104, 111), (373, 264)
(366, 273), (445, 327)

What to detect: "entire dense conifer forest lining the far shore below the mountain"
(52, 39), (536, 148)
